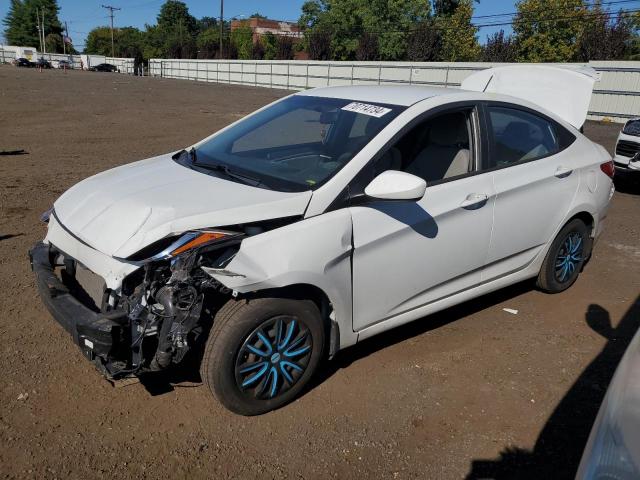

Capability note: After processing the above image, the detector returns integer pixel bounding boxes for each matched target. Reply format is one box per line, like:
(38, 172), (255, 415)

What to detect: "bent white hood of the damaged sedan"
(54, 154), (311, 258)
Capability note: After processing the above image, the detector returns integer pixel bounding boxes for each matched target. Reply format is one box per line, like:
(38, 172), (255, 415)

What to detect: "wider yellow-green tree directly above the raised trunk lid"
(513, 0), (586, 62)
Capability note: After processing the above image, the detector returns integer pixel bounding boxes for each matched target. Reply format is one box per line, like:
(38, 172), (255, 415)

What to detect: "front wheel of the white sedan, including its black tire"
(200, 298), (325, 415)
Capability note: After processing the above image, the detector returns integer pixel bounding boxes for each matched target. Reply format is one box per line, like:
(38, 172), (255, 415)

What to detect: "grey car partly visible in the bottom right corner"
(576, 322), (640, 480)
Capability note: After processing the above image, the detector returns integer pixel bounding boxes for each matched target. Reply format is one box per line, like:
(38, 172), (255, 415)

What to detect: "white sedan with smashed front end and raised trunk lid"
(30, 66), (614, 415)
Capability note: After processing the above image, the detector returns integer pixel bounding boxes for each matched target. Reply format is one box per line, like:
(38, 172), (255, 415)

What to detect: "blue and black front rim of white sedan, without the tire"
(235, 315), (313, 400)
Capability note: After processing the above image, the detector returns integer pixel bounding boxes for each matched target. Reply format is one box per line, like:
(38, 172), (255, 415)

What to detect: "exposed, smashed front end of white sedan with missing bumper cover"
(29, 227), (250, 380)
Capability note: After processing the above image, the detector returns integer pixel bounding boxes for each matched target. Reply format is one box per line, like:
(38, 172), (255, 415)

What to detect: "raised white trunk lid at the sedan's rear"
(461, 65), (598, 128)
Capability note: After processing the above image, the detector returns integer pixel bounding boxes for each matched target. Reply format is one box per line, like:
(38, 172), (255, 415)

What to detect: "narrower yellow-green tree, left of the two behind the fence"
(437, 0), (480, 62)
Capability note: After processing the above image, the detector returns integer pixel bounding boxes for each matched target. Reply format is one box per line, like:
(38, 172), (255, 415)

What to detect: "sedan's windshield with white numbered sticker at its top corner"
(191, 95), (405, 191)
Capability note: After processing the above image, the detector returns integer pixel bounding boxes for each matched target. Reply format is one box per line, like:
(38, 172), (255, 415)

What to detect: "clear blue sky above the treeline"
(0, 0), (532, 50)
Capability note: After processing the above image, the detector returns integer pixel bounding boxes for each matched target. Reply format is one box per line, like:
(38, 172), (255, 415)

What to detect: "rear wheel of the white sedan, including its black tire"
(537, 218), (592, 293)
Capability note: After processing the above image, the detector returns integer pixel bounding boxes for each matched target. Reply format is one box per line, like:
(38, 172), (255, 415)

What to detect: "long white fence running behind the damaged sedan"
(149, 59), (640, 122)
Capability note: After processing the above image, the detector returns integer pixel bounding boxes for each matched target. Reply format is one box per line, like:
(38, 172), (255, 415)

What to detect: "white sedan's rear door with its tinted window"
(483, 103), (580, 281)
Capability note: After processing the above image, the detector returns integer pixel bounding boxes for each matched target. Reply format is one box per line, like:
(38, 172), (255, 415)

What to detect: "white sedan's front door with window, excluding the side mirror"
(350, 108), (494, 331)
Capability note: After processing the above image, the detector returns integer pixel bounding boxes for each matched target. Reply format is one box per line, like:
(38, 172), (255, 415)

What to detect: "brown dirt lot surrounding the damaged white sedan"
(0, 67), (640, 479)
